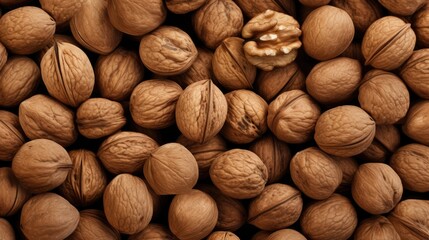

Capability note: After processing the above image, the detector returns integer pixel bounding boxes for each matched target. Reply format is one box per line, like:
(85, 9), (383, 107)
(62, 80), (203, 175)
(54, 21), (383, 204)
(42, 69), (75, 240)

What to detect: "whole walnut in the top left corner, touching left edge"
(0, 6), (55, 55)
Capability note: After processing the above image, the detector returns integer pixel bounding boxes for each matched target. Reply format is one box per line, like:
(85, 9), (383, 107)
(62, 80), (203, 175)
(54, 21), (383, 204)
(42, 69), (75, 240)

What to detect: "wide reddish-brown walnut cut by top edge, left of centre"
(107, 0), (167, 36)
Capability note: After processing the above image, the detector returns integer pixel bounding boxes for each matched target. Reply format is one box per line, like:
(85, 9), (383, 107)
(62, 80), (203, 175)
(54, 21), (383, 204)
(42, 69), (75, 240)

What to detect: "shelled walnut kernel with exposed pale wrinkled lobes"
(241, 10), (301, 71)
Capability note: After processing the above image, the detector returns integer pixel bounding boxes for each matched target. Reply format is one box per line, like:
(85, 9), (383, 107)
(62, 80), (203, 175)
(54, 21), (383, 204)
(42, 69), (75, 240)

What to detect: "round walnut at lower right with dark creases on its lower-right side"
(352, 163), (403, 214)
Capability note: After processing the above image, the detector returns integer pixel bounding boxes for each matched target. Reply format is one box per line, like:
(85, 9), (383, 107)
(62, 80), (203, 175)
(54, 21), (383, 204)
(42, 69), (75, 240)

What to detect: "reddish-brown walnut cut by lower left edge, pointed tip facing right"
(0, 167), (31, 217)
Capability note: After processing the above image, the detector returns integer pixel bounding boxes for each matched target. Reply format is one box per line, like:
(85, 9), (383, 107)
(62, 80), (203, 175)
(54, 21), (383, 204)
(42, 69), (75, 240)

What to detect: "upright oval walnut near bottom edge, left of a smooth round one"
(103, 173), (153, 234)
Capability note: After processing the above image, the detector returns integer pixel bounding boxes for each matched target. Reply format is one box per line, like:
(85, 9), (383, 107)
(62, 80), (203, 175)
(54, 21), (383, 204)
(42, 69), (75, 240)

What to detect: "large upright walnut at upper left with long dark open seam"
(40, 42), (95, 107)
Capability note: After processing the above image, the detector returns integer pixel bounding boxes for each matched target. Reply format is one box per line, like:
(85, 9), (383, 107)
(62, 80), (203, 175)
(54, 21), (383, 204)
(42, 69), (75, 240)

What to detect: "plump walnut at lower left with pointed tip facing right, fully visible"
(12, 139), (73, 193)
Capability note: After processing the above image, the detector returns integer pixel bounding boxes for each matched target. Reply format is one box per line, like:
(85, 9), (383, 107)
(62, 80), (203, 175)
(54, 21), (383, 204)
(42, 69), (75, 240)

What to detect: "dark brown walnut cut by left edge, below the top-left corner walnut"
(0, 56), (40, 107)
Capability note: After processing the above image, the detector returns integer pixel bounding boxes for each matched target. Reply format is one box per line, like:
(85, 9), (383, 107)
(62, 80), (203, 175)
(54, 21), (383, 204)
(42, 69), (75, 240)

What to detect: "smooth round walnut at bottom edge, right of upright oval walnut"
(168, 189), (218, 240)
